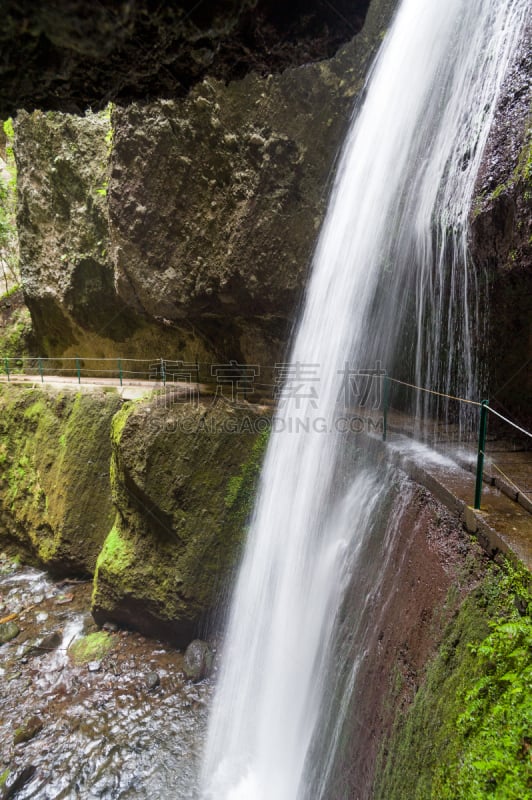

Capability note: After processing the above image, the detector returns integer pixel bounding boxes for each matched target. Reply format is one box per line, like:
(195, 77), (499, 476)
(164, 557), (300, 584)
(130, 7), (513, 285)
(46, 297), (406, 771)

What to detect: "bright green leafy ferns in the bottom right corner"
(432, 564), (532, 800)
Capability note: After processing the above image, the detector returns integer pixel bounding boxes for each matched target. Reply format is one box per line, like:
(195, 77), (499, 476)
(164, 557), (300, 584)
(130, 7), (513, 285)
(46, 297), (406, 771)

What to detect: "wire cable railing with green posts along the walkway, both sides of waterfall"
(0, 356), (532, 511)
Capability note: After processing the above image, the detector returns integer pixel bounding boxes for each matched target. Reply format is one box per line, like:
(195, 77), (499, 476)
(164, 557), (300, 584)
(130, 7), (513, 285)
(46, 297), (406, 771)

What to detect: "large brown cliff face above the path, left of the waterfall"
(12, 0), (394, 363)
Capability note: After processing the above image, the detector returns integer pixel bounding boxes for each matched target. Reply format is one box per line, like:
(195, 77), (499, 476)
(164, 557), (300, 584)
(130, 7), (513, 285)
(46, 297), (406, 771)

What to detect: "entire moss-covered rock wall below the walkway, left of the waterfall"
(0, 384), (269, 646)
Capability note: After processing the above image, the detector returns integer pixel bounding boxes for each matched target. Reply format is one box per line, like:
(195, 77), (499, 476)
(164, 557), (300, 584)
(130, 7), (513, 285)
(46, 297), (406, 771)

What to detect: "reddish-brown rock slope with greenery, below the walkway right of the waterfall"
(300, 462), (532, 800)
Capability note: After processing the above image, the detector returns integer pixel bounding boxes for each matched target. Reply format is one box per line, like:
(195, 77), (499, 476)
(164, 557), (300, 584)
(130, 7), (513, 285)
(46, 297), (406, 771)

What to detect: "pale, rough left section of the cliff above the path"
(16, 111), (117, 350)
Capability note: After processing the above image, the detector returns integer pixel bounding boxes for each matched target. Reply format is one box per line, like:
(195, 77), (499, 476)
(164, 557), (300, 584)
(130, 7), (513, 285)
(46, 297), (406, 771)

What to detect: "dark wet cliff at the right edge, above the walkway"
(471, 24), (532, 424)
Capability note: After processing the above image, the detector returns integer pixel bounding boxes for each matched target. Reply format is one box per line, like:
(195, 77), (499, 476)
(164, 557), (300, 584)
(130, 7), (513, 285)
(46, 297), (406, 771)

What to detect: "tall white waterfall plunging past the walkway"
(202, 0), (528, 800)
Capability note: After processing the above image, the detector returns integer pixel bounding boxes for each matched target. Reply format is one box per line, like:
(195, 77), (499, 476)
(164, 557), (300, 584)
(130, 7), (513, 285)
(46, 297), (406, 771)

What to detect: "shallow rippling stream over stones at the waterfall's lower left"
(0, 556), (212, 800)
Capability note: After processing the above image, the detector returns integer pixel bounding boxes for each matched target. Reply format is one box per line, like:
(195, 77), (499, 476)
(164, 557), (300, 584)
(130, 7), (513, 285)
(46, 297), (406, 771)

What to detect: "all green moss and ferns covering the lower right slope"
(375, 564), (532, 800)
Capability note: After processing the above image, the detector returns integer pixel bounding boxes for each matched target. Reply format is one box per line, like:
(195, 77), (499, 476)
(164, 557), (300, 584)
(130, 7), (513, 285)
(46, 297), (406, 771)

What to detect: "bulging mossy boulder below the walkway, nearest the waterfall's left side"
(93, 402), (267, 645)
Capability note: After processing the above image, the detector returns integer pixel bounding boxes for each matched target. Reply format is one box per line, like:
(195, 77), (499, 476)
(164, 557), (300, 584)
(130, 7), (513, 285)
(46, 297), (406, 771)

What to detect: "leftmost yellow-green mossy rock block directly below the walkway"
(0, 385), (121, 574)
